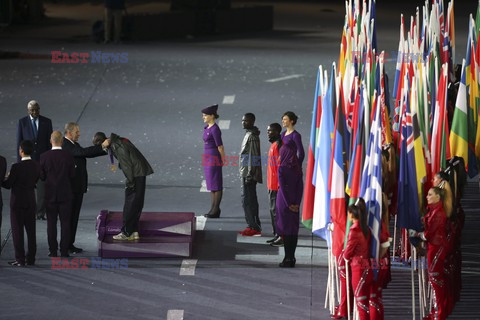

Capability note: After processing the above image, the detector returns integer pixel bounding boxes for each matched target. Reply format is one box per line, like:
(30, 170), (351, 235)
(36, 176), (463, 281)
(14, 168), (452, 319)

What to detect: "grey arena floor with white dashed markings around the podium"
(0, 1), (480, 319)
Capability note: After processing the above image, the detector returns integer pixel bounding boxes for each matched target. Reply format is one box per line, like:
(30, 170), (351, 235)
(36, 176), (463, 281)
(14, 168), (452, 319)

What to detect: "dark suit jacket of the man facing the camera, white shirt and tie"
(17, 116), (53, 162)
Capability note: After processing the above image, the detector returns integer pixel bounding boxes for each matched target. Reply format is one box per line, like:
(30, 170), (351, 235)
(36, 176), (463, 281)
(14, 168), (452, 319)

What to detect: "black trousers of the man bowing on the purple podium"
(122, 177), (146, 236)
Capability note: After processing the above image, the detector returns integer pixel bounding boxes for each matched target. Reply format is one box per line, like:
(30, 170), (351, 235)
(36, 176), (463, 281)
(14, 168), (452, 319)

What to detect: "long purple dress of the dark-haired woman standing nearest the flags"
(275, 140), (303, 236)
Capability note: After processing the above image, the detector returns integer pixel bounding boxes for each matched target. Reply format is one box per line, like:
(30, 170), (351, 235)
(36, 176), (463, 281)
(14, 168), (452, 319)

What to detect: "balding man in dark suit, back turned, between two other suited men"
(40, 131), (75, 257)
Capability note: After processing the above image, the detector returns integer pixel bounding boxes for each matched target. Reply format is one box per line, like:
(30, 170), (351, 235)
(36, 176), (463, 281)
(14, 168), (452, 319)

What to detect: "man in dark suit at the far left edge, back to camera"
(0, 140), (40, 267)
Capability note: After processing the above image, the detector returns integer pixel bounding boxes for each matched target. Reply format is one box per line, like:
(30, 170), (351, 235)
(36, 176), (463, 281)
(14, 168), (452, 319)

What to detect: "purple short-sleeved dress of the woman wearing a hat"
(202, 123), (223, 191)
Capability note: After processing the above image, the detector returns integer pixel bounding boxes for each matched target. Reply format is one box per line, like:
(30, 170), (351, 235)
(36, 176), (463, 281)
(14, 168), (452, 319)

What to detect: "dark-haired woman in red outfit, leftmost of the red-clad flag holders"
(343, 200), (372, 320)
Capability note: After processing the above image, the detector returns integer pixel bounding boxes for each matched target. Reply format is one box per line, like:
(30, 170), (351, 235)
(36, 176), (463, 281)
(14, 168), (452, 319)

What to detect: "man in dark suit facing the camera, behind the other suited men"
(17, 100), (53, 220)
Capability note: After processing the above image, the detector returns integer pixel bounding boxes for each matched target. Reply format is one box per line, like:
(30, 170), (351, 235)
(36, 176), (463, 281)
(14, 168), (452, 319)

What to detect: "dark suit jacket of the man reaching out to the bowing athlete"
(62, 138), (107, 193)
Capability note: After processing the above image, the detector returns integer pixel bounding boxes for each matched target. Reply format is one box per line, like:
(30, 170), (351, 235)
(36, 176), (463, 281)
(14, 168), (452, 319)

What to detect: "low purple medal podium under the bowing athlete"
(95, 210), (196, 258)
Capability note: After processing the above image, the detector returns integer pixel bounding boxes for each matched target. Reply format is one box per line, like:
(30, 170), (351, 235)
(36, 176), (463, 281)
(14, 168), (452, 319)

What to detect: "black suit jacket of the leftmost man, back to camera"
(2, 160), (40, 211)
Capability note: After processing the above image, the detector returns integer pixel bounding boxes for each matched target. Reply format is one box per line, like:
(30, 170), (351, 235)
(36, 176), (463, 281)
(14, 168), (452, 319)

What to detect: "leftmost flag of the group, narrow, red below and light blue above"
(302, 66), (323, 229)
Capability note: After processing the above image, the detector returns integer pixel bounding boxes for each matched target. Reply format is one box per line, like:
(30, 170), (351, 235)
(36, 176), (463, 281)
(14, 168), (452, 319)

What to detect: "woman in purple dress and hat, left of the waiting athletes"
(202, 104), (225, 218)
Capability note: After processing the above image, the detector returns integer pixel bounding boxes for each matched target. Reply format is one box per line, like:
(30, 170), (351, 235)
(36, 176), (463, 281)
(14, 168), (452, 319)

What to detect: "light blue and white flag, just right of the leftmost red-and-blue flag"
(312, 63), (336, 241)
